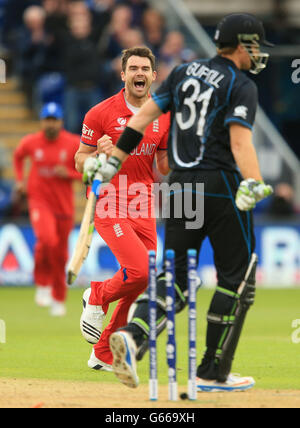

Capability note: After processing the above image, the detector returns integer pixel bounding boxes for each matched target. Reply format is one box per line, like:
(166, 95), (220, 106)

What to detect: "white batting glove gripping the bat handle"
(83, 154), (121, 184)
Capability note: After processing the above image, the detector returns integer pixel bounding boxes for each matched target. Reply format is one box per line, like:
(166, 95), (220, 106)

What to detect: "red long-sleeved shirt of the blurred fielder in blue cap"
(14, 130), (81, 217)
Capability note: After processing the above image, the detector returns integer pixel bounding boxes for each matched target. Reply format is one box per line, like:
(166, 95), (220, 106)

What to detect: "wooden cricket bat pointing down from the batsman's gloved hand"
(67, 155), (106, 285)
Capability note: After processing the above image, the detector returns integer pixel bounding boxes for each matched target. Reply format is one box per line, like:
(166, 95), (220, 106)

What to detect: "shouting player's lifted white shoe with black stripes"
(80, 288), (105, 345)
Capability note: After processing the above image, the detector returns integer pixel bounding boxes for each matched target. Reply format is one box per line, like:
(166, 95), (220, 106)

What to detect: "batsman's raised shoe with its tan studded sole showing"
(109, 331), (139, 388)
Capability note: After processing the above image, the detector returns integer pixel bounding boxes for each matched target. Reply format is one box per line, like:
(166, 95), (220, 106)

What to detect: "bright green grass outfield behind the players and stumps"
(0, 288), (300, 389)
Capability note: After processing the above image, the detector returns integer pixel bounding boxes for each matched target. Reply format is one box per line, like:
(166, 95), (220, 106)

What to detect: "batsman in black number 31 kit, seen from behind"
(84, 14), (272, 391)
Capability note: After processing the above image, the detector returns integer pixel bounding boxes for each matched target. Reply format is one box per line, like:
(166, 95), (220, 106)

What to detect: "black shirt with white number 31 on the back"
(153, 55), (258, 171)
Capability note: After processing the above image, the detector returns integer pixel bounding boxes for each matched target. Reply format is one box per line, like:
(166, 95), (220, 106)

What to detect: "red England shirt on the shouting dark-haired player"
(81, 89), (170, 217)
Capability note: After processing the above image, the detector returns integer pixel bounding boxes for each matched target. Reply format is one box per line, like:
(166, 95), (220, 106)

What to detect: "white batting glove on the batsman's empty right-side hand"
(235, 178), (273, 211)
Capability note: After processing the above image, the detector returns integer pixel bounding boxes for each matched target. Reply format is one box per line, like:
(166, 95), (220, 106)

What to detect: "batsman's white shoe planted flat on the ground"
(197, 374), (255, 392)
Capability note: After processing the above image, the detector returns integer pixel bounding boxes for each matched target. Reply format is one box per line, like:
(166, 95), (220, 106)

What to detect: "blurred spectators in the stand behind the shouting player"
(0, 0), (195, 133)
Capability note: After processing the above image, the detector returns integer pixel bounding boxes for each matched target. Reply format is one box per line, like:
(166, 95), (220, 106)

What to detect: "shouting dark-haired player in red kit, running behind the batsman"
(75, 47), (170, 370)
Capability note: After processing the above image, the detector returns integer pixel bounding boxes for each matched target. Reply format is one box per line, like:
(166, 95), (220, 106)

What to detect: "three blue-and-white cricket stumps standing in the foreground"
(148, 250), (197, 401)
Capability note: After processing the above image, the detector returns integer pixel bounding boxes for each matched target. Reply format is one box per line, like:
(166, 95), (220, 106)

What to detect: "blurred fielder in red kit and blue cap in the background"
(14, 103), (81, 316)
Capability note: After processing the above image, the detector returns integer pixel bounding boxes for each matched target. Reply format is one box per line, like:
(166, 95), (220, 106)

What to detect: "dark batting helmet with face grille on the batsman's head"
(214, 13), (273, 74)
